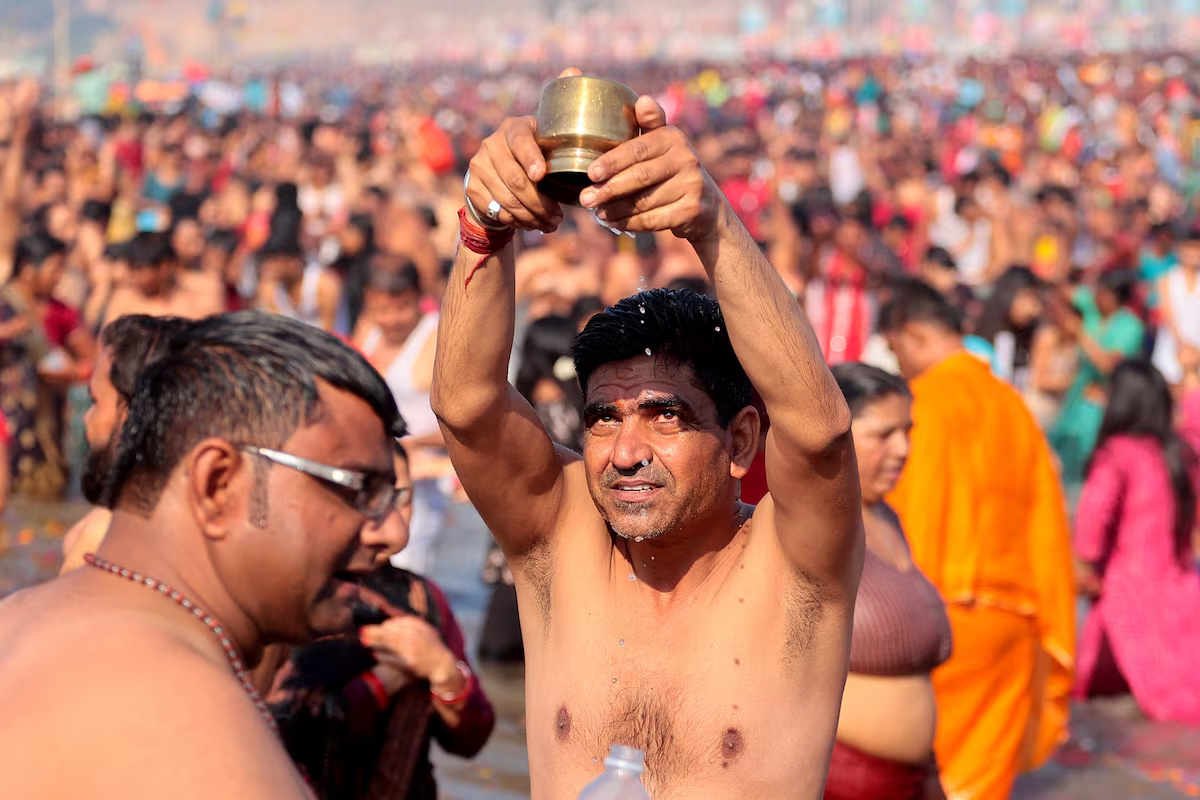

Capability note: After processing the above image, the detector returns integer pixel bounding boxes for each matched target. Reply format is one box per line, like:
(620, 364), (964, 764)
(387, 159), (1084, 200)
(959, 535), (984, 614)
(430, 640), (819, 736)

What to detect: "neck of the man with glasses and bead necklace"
(96, 510), (263, 669)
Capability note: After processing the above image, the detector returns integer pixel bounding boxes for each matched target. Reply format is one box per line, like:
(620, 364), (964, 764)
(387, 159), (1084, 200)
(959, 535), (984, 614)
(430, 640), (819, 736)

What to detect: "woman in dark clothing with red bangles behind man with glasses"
(264, 443), (496, 800)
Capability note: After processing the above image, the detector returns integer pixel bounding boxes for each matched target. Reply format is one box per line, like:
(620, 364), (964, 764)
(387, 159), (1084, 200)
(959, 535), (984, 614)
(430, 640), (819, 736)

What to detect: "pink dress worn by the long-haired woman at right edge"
(1075, 435), (1200, 723)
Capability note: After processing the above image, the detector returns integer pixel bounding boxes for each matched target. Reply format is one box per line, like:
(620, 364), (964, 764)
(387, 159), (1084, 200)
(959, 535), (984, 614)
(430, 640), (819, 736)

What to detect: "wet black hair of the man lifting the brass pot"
(571, 289), (750, 427)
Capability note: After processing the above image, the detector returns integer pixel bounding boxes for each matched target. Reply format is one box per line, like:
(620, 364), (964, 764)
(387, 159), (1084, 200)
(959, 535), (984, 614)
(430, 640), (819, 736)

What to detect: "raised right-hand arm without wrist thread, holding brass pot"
(580, 97), (863, 597)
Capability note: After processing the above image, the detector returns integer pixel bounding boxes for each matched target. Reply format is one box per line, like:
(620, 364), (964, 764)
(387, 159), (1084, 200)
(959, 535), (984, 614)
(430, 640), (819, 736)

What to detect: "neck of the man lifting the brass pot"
(614, 500), (754, 606)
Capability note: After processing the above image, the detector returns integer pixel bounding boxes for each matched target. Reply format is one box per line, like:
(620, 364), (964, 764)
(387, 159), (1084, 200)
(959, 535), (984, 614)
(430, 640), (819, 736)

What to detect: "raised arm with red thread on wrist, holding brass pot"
(431, 101), (570, 558)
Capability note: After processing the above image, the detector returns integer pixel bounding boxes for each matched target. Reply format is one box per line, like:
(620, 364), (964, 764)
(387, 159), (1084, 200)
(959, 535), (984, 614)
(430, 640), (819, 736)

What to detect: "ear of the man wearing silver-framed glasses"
(184, 438), (254, 540)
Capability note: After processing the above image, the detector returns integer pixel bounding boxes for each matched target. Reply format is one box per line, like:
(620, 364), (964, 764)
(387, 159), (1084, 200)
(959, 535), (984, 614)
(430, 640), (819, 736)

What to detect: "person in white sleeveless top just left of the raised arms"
(355, 262), (454, 575)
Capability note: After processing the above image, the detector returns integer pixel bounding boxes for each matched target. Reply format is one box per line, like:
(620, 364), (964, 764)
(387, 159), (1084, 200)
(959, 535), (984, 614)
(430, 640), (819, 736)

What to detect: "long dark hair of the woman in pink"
(1087, 360), (1196, 570)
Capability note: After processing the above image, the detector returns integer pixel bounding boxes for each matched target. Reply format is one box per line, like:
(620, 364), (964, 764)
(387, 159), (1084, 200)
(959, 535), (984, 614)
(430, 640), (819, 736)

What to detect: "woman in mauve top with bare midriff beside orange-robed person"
(824, 363), (950, 800)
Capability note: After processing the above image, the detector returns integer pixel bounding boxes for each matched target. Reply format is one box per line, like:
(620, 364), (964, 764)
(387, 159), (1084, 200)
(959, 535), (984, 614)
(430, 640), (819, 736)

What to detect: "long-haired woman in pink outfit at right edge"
(1075, 361), (1200, 723)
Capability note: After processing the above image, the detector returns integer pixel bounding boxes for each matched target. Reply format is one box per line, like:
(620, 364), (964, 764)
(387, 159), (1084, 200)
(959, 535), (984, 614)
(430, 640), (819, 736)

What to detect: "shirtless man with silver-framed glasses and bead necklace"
(0, 312), (402, 799)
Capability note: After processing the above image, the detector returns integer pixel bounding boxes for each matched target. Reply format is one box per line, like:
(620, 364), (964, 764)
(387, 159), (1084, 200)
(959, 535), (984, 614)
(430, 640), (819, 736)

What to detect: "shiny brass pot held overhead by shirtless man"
(538, 77), (640, 205)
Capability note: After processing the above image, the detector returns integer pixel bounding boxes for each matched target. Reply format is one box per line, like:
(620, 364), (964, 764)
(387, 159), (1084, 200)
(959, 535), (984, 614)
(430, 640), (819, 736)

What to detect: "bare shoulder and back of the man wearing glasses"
(0, 609), (306, 799)
